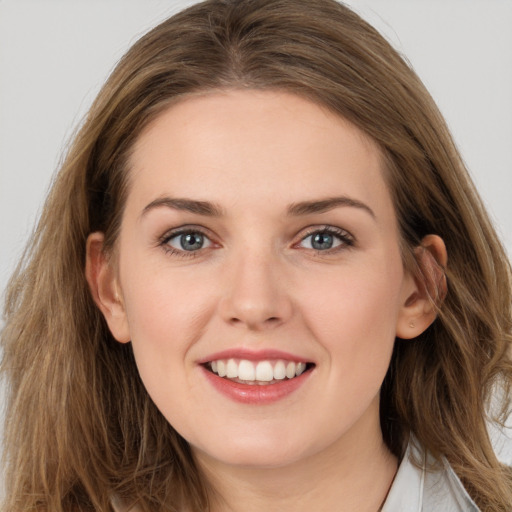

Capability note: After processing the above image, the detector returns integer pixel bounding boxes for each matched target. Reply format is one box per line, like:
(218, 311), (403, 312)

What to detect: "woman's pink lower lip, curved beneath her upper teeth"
(203, 368), (311, 405)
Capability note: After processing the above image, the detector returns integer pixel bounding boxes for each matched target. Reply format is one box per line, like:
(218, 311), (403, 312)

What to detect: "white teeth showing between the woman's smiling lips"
(204, 359), (315, 386)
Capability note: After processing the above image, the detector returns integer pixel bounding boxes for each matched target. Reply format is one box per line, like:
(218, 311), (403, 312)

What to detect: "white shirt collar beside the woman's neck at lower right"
(381, 441), (479, 512)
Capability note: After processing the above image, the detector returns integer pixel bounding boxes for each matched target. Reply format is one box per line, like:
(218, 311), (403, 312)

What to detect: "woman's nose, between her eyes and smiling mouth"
(220, 254), (293, 331)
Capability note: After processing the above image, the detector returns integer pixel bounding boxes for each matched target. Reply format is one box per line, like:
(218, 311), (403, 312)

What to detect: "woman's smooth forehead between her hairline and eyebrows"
(129, 90), (390, 218)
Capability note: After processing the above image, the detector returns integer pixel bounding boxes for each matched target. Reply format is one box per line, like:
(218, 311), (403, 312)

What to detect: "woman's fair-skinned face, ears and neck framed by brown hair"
(86, 90), (446, 512)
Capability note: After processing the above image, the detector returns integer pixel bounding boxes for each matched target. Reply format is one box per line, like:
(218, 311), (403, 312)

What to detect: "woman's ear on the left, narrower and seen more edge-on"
(85, 232), (130, 343)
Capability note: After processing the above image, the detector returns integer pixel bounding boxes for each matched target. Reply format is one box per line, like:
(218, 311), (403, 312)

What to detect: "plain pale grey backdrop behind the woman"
(0, 0), (512, 496)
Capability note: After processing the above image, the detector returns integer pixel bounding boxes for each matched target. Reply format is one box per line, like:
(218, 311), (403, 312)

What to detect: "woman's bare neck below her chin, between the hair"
(197, 404), (397, 512)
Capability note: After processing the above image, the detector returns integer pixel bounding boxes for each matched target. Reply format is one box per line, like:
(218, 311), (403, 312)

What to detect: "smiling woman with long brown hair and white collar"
(2, 0), (512, 512)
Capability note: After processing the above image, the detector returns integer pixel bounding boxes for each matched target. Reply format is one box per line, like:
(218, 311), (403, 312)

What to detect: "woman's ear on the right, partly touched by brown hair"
(396, 235), (448, 339)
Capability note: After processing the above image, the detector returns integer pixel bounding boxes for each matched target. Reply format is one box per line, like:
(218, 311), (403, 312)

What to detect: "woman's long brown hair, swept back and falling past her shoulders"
(1, 0), (512, 512)
